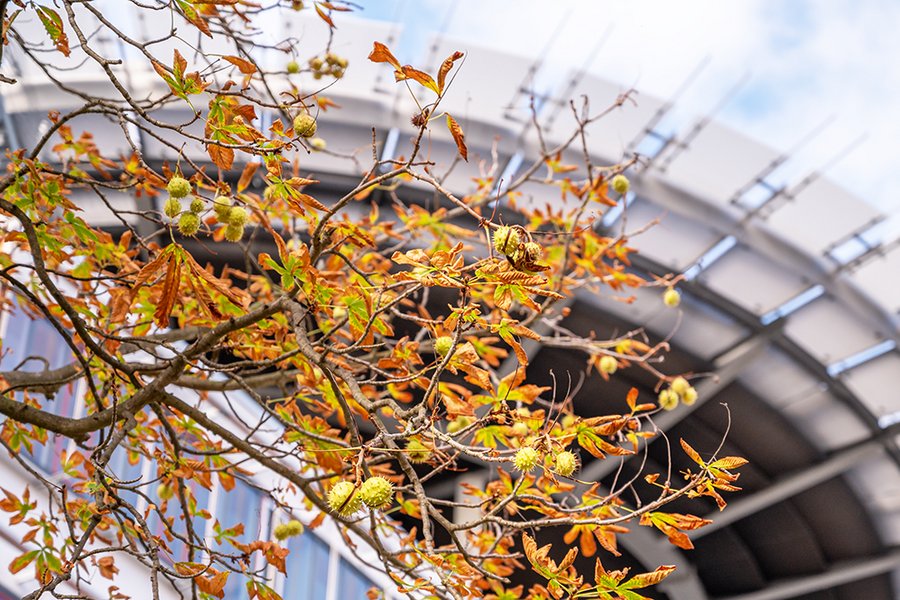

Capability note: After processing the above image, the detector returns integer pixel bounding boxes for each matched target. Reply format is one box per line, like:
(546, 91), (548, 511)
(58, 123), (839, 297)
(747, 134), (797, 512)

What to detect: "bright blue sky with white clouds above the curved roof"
(360, 0), (900, 225)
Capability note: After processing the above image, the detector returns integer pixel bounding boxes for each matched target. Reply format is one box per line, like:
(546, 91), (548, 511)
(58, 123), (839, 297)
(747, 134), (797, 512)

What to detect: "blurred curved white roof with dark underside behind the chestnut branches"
(2, 9), (900, 600)
